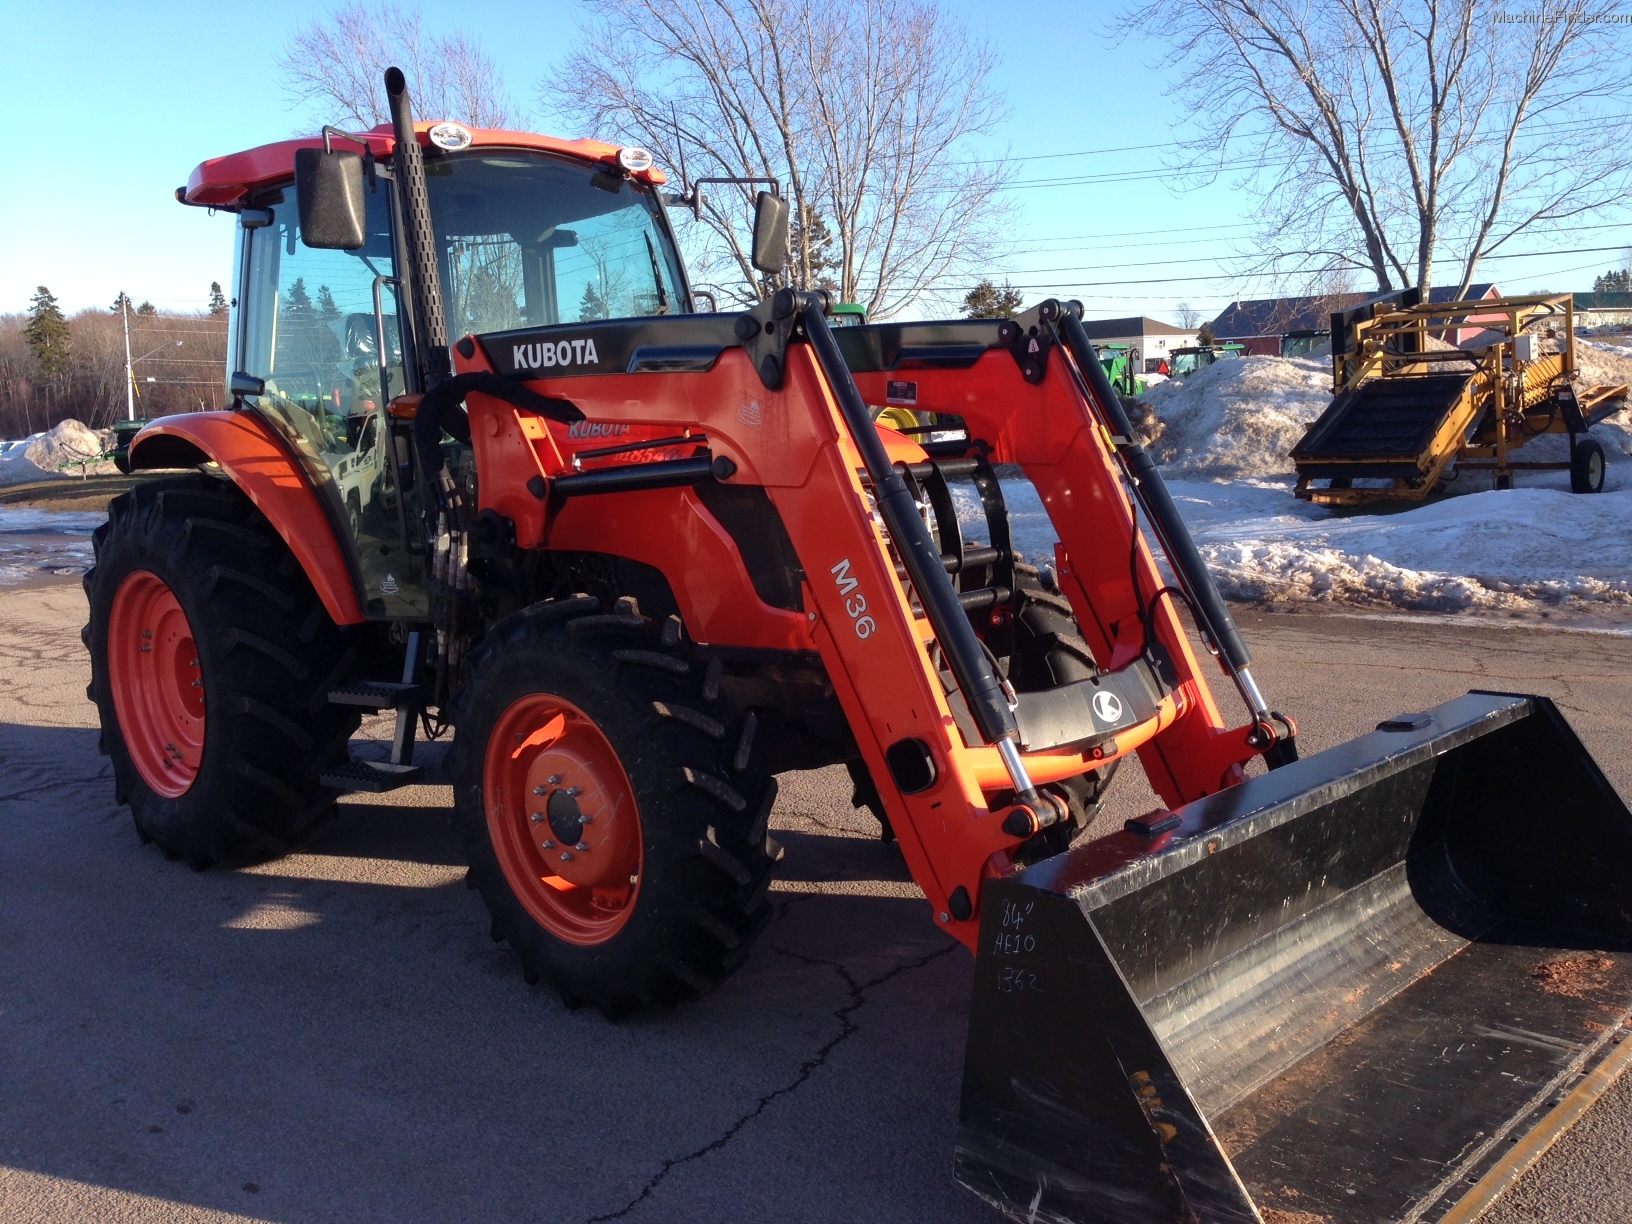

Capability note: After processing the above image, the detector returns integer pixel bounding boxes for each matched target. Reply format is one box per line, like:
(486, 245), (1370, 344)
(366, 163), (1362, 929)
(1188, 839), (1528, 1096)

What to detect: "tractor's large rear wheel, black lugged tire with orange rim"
(82, 475), (357, 870)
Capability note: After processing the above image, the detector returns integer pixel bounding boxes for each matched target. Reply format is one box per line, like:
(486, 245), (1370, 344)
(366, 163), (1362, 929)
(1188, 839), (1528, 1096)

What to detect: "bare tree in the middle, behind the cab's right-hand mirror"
(540, 0), (1010, 318)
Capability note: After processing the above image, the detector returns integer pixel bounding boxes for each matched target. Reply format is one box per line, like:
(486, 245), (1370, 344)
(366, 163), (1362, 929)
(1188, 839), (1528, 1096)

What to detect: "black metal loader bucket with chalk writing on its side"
(956, 692), (1632, 1224)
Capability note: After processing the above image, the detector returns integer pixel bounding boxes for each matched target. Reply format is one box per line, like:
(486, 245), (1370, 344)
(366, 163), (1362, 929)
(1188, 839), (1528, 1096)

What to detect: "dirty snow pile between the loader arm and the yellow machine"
(1142, 357), (1332, 480)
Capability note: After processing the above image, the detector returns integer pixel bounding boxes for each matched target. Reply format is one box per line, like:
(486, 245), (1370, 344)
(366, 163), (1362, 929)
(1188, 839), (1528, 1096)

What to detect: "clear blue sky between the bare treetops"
(0, 0), (1632, 318)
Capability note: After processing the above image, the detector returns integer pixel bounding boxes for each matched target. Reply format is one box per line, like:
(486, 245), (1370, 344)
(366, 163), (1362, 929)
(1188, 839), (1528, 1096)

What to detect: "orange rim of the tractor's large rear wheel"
(108, 570), (204, 800)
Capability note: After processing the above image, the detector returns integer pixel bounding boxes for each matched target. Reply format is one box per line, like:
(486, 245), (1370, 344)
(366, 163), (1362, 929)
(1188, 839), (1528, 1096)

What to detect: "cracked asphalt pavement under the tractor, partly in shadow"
(0, 584), (1632, 1224)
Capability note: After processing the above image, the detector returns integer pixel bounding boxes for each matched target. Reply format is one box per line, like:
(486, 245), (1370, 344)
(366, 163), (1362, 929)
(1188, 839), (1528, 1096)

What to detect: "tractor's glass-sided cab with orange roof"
(189, 124), (694, 619)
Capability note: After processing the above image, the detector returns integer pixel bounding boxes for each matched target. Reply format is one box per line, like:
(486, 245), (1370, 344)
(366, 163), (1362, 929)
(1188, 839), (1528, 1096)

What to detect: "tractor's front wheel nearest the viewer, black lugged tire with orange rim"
(452, 596), (775, 1015)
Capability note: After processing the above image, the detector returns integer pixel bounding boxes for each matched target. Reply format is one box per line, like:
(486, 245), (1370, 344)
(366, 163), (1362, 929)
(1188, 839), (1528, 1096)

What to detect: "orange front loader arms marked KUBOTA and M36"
(455, 297), (1263, 947)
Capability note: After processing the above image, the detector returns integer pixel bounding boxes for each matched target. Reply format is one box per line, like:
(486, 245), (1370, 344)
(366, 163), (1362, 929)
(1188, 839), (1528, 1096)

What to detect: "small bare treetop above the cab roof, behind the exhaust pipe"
(277, 0), (517, 127)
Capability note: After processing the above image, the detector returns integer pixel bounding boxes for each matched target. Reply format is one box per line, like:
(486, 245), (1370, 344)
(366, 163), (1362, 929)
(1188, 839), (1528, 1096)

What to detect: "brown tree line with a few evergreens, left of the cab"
(0, 284), (227, 437)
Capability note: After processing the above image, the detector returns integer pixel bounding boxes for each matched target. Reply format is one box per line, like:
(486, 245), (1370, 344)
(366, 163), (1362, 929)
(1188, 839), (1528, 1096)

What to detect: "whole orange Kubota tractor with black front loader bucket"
(85, 69), (1632, 1224)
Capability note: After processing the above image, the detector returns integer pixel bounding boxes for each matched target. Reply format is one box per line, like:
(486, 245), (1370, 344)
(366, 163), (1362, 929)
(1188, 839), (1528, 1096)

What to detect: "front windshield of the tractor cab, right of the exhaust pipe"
(424, 150), (690, 338)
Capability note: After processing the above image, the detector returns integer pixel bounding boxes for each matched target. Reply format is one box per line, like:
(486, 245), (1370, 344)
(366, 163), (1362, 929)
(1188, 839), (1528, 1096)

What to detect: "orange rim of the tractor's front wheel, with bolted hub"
(481, 694), (641, 945)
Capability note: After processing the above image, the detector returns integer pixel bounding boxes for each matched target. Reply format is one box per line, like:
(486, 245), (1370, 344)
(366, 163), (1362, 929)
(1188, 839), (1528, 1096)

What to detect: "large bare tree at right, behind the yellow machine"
(1123, 0), (1632, 297)
